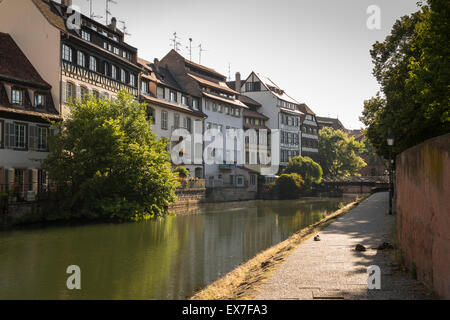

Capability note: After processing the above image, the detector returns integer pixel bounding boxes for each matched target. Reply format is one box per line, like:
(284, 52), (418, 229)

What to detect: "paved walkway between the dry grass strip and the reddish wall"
(256, 193), (430, 300)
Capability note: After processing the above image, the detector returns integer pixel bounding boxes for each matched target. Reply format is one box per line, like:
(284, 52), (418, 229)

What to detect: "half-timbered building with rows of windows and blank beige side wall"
(0, 0), (141, 116)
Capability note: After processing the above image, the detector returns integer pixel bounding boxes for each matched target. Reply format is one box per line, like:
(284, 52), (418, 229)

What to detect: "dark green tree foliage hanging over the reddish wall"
(361, 0), (450, 159)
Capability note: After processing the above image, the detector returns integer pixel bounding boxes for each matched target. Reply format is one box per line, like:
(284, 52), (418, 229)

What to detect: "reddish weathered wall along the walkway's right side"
(396, 134), (450, 299)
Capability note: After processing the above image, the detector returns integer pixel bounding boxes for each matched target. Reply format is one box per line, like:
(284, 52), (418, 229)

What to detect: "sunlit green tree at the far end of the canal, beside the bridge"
(319, 127), (366, 178)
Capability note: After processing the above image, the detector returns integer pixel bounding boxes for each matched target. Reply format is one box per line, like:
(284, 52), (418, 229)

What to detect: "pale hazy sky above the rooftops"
(73, 0), (418, 129)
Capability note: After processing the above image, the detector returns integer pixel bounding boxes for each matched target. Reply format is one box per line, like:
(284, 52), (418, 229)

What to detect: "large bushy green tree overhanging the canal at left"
(43, 92), (177, 220)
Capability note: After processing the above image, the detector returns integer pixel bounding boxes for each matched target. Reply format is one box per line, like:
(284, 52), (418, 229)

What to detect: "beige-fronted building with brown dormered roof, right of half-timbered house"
(138, 58), (206, 179)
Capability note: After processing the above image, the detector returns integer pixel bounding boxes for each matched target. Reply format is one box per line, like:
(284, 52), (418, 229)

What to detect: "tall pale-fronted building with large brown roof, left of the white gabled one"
(157, 50), (257, 194)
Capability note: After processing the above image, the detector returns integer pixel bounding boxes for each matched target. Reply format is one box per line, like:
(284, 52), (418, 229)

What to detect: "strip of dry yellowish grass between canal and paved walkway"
(191, 195), (369, 300)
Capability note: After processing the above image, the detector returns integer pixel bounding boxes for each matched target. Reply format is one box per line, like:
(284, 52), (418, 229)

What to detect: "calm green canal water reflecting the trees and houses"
(0, 197), (354, 299)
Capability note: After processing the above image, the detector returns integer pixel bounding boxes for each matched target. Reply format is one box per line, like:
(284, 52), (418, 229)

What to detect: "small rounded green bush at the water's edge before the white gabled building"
(283, 156), (323, 190)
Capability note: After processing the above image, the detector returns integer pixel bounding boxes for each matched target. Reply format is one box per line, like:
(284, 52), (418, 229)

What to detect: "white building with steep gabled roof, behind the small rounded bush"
(236, 72), (304, 167)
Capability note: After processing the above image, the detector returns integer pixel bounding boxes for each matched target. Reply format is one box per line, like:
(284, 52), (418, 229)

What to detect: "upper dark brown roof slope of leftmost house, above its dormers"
(0, 32), (51, 89)
